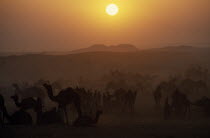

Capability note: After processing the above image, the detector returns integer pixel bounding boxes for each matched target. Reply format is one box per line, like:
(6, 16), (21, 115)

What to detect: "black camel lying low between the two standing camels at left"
(34, 98), (64, 125)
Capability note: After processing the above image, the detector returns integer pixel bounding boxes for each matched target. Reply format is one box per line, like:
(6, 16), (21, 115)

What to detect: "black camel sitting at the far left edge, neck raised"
(0, 96), (32, 125)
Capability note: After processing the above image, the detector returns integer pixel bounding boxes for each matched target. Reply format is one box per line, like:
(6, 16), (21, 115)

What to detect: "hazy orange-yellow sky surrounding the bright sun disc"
(0, 0), (210, 51)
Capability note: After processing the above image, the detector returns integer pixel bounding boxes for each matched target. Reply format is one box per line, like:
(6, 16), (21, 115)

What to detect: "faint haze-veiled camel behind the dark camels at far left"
(13, 84), (45, 99)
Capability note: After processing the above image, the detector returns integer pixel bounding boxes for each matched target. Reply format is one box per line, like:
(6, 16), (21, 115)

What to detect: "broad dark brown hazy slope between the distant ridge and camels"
(0, 46), (210, 83)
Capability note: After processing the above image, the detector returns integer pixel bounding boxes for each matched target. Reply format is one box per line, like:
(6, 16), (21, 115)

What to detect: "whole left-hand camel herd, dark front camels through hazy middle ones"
(0, 83), (137, 126)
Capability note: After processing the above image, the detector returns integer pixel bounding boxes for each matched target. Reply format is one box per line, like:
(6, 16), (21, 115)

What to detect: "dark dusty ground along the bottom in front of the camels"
(0, 115), (210, 138)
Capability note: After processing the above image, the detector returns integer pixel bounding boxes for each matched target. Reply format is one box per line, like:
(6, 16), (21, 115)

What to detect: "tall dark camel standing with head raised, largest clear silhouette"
(43, 84), (82, 124)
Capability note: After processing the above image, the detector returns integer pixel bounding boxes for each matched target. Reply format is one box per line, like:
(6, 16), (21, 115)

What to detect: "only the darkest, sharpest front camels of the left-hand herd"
(0, 84), (102, 126)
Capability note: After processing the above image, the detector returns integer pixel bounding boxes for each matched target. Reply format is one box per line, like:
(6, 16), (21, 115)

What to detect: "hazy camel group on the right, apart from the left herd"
(153, 79), (210, 119)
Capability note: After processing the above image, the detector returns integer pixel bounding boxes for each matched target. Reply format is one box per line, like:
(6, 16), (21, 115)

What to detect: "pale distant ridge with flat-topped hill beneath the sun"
(0, 44), (210, 56)
